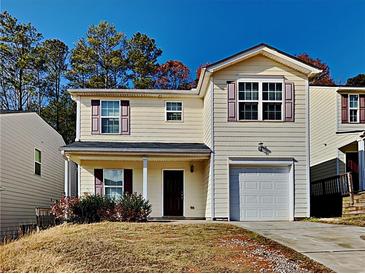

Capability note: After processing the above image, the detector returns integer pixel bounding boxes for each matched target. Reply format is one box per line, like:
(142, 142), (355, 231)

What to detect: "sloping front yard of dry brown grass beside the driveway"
(0, 222), (330, 272)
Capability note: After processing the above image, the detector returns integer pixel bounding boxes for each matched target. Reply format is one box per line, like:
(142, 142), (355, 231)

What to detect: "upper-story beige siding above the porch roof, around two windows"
(81, 97), (203, 143)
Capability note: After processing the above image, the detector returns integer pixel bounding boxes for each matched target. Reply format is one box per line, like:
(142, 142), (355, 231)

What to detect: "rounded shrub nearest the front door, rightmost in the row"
(116, 193), (152, 222)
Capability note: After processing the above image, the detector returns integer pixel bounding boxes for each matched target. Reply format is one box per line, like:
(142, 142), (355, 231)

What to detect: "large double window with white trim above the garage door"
(237, 79), (284, 121)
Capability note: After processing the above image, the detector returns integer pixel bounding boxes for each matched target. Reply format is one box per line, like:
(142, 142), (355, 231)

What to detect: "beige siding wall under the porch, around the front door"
(81, 160), (207, 218)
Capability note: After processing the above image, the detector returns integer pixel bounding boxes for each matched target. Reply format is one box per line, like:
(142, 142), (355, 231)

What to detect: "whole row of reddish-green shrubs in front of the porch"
(52, 193), (152, 223)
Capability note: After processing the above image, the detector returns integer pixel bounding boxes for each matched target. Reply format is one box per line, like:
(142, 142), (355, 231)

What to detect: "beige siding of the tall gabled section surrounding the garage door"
(213, 56), (309, 218)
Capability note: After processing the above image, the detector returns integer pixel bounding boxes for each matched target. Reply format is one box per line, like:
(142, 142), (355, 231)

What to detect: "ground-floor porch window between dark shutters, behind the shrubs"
(103, 169), (124, 199)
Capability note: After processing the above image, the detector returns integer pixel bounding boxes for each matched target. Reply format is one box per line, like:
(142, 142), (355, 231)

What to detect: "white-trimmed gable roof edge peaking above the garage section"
(206, 43), (322, 76)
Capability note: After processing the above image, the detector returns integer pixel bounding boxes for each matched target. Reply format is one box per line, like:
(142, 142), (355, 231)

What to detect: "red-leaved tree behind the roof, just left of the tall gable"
(155, 60), (191, 89)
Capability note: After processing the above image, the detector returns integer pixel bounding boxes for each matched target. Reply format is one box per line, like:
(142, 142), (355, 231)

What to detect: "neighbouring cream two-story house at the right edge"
(310, 86), (365, 191)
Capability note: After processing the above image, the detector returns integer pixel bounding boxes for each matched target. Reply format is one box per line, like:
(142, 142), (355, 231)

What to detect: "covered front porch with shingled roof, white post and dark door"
(62, 142), (211, 218)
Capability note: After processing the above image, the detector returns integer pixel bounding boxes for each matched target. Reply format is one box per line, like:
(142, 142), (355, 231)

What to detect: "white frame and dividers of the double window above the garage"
(236, 77), (285, 122)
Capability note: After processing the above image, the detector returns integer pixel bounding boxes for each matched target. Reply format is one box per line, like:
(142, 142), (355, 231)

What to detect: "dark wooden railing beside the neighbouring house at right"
(311, 172), (354, 203)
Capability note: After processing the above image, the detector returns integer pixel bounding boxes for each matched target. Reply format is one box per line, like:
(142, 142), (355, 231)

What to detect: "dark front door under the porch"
(163, 170), (184, 216)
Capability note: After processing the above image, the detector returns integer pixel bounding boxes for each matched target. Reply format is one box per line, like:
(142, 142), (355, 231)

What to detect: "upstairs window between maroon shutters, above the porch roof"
(100, 101), (120, 134)
